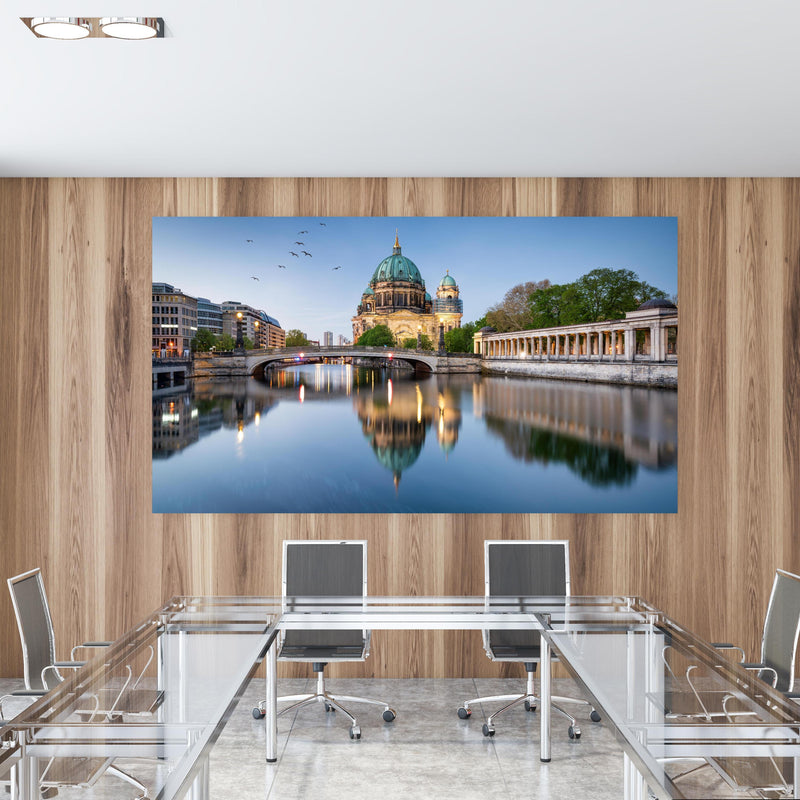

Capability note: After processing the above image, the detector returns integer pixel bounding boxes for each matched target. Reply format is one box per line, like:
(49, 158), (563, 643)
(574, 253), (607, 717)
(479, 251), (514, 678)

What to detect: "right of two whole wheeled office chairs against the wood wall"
(458, 540), (600, 739)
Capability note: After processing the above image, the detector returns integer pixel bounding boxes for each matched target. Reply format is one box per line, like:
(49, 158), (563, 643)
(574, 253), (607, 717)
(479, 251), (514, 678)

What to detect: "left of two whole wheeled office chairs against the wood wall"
(253, 540), (396, 739)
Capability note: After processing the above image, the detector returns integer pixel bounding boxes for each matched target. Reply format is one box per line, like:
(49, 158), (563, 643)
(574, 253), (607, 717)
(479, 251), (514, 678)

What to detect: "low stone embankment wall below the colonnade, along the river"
(483, 358), (678, 389)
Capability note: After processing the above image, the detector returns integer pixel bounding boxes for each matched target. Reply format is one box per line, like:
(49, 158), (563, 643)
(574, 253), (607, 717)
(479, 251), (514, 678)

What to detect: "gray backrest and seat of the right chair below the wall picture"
(484, 540), (569, 661)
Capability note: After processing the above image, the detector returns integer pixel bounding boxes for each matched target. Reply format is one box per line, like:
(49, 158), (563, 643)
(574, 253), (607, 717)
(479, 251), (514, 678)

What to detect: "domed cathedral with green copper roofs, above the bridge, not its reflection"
(353, 235), (464, 347)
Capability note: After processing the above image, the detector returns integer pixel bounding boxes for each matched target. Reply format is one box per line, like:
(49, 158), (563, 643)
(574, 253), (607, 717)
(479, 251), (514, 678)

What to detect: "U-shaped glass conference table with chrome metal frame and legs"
(0, 597), (800, 800)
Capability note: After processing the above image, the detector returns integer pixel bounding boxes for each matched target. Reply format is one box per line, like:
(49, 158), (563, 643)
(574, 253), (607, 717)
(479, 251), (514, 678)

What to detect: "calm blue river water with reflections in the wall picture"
(153, 364), (678, 513)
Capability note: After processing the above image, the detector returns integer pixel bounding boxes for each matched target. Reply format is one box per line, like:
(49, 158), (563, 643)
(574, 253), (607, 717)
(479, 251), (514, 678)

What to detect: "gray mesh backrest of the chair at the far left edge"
(8, 568), (59, 690)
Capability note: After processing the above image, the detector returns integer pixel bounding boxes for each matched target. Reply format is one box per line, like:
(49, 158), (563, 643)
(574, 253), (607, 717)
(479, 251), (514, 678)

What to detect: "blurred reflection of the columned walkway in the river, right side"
(473, 381), (678, 468)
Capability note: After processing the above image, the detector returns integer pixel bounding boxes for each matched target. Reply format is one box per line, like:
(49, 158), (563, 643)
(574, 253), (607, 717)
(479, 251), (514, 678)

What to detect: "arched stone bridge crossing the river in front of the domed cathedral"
(194, 345), (481, 378)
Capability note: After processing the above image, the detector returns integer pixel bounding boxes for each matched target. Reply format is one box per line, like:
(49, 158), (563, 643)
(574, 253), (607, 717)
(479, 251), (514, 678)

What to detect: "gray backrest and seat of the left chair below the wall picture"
(282, 540), (367, 660)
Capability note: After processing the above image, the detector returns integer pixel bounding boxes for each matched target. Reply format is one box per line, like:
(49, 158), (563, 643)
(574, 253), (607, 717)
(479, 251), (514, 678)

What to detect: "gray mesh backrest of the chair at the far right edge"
(761, 569), (800, 692)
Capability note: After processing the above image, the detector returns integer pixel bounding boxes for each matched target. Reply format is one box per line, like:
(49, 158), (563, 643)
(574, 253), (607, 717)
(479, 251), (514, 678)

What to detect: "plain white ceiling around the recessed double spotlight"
(0, 0), (800, 176)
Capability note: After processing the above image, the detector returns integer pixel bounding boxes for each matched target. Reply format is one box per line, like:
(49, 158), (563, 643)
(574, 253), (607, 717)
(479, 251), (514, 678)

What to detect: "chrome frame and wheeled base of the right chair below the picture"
(458, 539), (600, 739)
